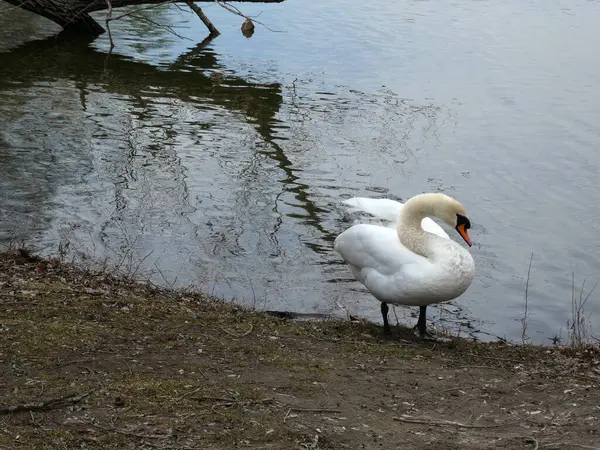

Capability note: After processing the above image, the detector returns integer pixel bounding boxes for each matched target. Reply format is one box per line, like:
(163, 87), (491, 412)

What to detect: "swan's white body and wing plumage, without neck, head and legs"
(334, 197), (475, 306)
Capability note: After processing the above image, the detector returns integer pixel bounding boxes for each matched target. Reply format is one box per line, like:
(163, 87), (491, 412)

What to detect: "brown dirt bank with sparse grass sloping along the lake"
(0, 252), (600, 450)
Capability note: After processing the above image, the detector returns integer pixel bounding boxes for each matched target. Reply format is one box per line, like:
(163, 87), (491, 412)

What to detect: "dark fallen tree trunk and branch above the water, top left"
(5, 0), (285, 36)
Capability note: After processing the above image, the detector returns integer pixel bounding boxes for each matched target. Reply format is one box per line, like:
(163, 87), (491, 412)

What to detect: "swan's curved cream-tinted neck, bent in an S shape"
(397, 194), (435, 258)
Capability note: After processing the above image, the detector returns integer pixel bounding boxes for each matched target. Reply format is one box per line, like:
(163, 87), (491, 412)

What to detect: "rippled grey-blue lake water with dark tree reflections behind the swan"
(0, 0), (600, 343)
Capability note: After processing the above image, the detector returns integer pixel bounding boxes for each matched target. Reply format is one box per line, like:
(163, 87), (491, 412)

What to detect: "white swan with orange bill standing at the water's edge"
(333, 193), (475, 337)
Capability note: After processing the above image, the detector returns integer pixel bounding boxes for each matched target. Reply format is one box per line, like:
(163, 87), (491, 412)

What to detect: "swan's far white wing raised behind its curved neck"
(342, 197), (450, 239)
